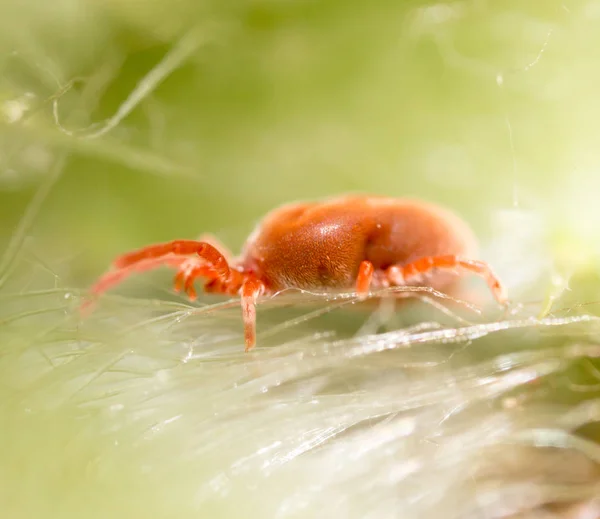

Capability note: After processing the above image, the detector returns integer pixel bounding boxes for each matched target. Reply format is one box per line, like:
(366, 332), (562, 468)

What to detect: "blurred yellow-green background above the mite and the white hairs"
(0, 0), (600, 286)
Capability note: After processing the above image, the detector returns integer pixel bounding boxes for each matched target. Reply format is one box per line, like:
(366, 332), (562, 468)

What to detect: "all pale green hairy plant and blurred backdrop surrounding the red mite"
(0, 0), (600, 519)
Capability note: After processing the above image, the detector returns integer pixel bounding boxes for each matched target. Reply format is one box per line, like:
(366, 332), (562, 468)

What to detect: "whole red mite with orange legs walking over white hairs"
(84, 196), (507, 351)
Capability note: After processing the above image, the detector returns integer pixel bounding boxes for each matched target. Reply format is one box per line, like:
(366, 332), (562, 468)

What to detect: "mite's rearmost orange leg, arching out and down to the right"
(386, 255), (508, 305)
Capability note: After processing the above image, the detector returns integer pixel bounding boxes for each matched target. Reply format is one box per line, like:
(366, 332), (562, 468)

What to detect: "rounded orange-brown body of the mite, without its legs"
(240, 196), (476, 291)
